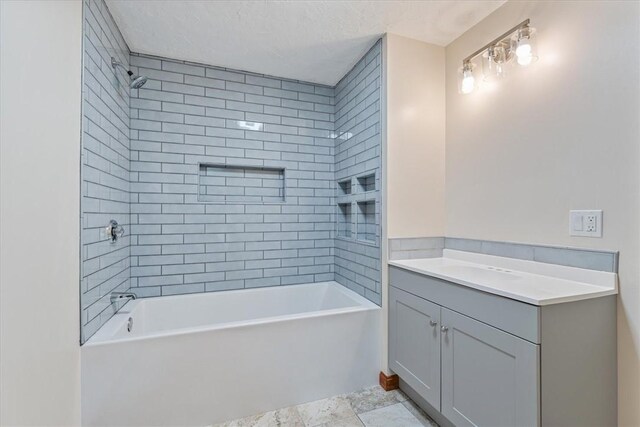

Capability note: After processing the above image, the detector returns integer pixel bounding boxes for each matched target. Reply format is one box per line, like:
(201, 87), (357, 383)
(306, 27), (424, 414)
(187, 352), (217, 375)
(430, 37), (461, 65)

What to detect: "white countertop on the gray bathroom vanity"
(389, 249), (618, 306)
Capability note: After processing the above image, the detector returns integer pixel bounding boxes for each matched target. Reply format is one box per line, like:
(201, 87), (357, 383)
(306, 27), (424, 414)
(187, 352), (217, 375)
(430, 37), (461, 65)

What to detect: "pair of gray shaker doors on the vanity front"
(389, 286), (539, 427)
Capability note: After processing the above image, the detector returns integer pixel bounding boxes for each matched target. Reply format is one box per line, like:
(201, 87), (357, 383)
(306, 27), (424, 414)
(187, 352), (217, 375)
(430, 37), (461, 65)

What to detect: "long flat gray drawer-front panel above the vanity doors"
(389, 266), (540, 344)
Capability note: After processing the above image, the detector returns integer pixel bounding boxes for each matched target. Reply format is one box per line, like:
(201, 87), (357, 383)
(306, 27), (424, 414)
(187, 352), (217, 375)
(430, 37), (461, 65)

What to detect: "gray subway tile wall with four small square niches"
(333, 41), (382, 305)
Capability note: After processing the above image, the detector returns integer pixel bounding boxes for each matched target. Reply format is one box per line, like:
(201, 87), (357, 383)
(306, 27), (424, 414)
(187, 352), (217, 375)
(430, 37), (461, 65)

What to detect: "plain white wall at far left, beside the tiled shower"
(0, 1), (82, 425)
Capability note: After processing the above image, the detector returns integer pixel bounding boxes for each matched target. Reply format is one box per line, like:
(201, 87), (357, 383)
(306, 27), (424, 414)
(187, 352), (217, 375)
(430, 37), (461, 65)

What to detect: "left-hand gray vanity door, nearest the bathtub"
(389, 287), (440, 409)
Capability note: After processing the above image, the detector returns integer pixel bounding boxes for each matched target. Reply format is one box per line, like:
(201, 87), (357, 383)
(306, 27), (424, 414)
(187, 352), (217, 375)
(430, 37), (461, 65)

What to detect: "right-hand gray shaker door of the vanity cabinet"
(441, 308), (540, 427)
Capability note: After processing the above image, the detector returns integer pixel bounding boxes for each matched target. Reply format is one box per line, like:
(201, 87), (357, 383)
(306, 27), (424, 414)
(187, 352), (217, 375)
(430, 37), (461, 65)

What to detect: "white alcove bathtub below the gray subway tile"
(81, 282), (381, 426)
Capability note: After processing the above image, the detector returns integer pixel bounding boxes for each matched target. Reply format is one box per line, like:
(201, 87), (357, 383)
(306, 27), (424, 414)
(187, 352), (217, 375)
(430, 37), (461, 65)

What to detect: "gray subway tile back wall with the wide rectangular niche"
(131, 54), (335, 296)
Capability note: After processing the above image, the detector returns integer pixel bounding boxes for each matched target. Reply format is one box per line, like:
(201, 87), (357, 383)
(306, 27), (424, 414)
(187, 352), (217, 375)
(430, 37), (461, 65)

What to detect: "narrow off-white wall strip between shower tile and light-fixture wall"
(386, 34), (445, 238)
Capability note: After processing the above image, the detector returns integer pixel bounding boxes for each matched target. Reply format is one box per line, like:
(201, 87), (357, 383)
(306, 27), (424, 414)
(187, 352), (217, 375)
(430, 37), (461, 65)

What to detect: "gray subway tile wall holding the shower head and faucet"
(81, 0), (130, 341)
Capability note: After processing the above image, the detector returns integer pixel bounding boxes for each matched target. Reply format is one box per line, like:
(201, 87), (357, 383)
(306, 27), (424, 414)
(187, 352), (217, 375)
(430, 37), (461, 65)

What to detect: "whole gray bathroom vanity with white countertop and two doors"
(389, 250), (617, 427)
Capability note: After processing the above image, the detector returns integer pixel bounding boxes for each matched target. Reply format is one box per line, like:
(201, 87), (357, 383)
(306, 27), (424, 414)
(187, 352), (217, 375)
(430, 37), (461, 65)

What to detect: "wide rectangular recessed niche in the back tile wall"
(198, 163), (285, 203)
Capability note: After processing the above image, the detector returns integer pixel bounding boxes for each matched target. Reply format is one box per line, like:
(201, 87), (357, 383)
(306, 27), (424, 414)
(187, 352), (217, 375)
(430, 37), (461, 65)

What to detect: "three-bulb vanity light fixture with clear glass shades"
(458, 19), (538, 95)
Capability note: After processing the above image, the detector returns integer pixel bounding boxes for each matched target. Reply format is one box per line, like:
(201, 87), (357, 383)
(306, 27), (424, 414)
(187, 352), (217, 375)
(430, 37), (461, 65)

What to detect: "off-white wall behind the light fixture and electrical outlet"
(446, 1), (640, 426)
